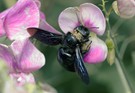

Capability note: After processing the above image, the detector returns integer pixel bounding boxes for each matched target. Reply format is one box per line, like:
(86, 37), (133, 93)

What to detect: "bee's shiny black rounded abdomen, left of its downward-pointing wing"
(58, 47), (75, 72)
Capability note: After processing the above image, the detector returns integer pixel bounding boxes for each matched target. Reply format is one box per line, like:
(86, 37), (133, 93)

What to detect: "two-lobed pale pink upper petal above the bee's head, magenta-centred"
(58, 3), (106, 35)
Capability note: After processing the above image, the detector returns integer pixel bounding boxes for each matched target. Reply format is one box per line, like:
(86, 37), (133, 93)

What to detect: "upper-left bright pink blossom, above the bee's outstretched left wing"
(0, 0), (60, 40)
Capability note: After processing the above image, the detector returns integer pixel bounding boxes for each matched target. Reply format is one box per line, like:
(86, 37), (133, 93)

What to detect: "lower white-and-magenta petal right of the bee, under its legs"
(84, 37), (108, 64)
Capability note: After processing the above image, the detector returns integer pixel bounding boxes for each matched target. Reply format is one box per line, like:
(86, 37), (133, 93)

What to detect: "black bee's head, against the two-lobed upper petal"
(75, 26), (90, 38)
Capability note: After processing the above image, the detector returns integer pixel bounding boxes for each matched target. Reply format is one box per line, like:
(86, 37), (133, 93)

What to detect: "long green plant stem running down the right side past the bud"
(101, 0), (133, 93)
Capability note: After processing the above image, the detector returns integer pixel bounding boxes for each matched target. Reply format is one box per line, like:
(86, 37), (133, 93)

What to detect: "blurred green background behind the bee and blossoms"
(0, 0), (135, 93)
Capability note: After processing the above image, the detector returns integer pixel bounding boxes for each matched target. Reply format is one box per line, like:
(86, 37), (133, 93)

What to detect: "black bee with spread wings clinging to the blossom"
(28, 26), (92, 84)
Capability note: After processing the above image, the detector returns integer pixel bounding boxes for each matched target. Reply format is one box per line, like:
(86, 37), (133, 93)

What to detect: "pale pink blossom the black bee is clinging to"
(58, 3), (107, 63)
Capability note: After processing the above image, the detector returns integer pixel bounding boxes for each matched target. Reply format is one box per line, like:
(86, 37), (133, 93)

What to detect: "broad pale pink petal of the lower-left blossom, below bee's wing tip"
(10, 39), (45, 73)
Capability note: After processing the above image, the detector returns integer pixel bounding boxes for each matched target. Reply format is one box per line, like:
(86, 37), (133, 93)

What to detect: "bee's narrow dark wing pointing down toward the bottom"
(74, 46), (89, 84)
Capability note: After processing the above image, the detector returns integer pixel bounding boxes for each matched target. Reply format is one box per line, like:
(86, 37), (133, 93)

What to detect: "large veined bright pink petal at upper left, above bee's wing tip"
(4, 0), (40, 40)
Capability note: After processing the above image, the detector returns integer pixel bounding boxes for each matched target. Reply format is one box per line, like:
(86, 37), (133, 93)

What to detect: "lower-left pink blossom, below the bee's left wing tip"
(0, 39), (45, 84)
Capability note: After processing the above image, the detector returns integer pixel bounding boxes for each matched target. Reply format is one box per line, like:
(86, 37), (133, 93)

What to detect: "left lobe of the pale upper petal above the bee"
(58, 7), (80, 33)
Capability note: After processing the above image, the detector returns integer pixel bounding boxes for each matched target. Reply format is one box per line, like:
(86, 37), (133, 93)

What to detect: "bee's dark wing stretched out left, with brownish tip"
(27, 28), (63, 45)
